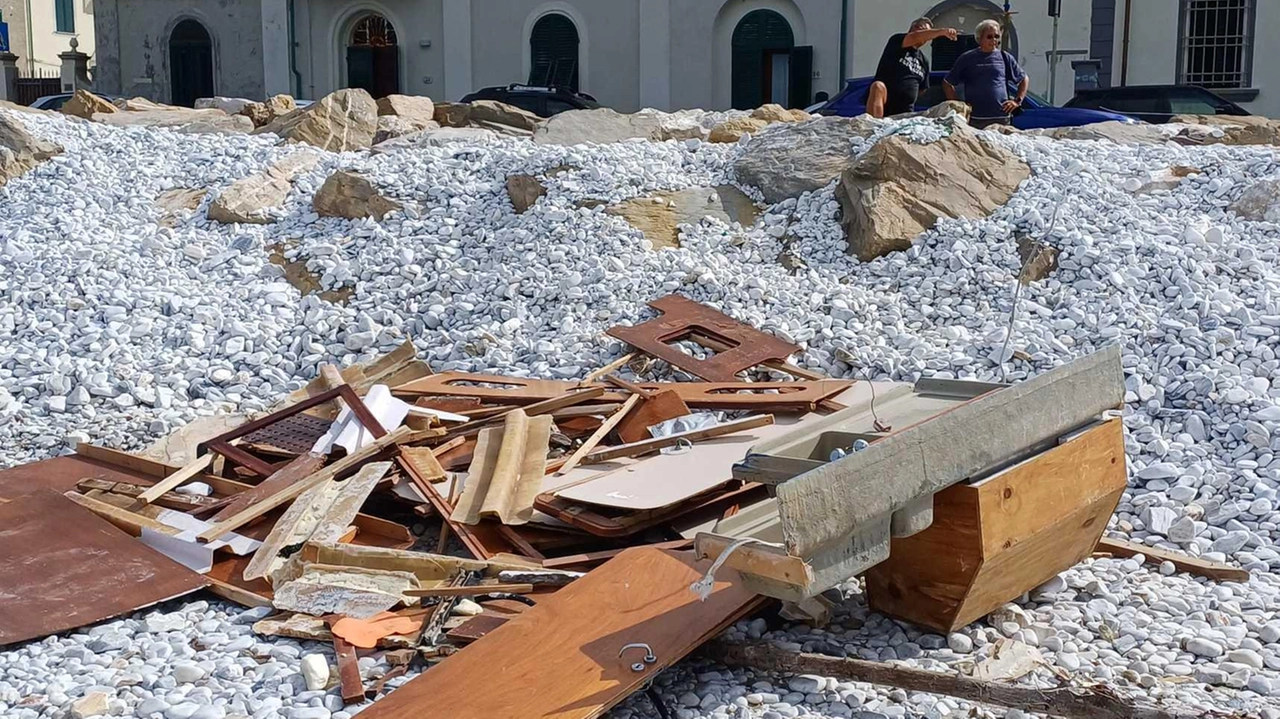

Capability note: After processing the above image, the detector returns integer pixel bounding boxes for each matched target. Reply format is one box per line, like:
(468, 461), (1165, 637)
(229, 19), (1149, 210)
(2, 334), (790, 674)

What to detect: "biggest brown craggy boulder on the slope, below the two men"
(836, 123), (1030, 261)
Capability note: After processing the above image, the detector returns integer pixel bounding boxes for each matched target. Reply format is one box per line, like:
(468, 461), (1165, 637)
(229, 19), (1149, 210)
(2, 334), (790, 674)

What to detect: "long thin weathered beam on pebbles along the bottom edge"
(703, 641), (1187, 719)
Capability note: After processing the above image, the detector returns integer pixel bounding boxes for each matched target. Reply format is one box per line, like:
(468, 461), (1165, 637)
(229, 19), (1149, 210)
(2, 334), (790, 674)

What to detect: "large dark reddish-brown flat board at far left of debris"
(0, 490), (207, 646)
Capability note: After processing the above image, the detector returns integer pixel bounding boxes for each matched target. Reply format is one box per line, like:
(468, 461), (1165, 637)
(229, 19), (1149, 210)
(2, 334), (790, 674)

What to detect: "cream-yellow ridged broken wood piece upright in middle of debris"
(452, 409), (552, 525)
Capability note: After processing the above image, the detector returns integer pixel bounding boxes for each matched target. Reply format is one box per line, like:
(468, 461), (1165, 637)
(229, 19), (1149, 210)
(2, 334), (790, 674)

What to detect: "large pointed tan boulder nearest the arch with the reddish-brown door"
(253, 88), (378, 152)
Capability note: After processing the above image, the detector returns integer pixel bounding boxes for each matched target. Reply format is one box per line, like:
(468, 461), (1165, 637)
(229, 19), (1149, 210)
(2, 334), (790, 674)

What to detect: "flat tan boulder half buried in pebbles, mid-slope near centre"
(605, 184), (758, 248)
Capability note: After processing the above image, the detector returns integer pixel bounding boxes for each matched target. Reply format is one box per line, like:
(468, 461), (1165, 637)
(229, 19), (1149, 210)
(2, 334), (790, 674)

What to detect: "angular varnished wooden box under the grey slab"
(865, 418), (1126, 632)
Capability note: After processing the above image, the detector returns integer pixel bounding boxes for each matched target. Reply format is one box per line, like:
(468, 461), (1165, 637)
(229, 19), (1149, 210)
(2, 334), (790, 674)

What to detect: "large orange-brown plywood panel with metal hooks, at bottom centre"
(361, 548), (759, 719)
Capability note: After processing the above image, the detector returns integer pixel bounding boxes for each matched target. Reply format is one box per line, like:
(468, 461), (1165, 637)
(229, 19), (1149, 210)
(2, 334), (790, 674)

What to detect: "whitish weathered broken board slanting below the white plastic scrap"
(244, 462), (392, 585)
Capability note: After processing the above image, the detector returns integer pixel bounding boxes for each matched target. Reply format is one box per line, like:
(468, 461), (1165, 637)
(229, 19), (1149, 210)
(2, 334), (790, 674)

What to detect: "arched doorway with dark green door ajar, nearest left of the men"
(731, 10), (795, 110)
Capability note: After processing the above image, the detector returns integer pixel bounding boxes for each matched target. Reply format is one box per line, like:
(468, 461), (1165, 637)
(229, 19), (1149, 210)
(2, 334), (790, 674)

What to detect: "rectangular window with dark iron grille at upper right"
(1178, 0), (1257, 88)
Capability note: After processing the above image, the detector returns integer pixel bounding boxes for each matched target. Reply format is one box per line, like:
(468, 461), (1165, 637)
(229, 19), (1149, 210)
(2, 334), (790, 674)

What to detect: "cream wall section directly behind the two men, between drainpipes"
(850, 0), (1095, 104)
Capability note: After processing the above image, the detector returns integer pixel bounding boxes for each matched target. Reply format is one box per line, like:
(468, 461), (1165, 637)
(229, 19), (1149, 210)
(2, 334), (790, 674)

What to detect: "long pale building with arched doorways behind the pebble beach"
(87, 0), (1280, 111)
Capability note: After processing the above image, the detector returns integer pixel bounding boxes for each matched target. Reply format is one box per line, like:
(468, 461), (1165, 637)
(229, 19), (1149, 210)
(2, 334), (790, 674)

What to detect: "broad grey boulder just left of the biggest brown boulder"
(733, 115), (876, 205)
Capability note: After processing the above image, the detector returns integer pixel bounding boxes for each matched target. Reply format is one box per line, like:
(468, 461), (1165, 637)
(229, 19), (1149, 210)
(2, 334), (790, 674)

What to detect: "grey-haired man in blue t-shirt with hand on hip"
(942, 20), (1030, 129)
